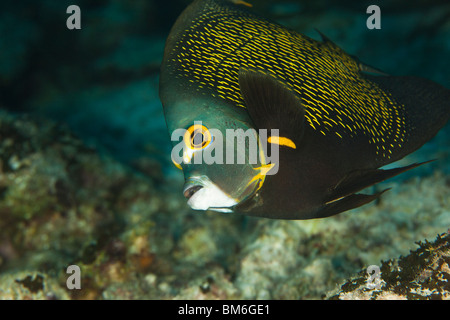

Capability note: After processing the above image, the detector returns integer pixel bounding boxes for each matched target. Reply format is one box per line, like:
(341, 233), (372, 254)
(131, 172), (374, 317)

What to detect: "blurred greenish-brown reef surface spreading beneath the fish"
(0, 112), (450, 299)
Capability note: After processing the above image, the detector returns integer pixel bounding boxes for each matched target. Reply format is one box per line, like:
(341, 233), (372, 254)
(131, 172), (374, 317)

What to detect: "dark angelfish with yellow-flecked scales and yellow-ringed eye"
(159, 0), (450, 220)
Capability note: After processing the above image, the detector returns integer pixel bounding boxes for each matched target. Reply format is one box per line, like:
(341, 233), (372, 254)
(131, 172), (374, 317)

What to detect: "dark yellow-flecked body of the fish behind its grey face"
(161, 0), (450, 218)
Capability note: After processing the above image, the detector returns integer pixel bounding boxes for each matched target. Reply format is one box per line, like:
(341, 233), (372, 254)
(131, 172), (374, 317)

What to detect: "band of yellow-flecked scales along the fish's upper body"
(168, 3), (407, 159)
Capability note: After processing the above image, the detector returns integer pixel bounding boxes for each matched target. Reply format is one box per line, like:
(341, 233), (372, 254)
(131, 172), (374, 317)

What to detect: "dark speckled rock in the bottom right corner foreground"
(328, 229), (450, 300)
